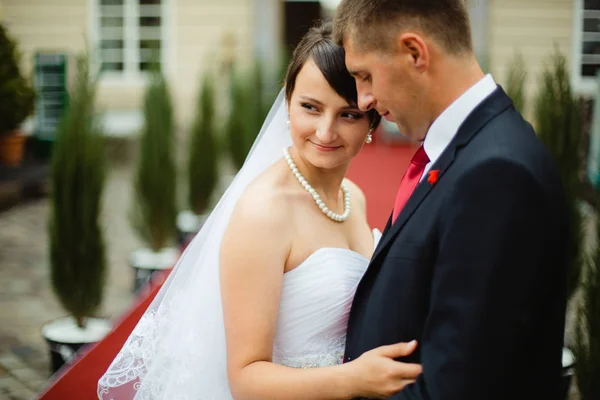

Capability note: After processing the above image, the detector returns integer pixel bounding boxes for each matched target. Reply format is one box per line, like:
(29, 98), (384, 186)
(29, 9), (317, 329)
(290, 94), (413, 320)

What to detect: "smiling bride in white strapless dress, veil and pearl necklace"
(98, 24), (421, 400)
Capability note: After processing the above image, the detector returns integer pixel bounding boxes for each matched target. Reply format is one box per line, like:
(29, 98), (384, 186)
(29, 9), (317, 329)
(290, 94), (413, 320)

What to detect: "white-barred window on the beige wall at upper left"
(96, 0), (166, 77)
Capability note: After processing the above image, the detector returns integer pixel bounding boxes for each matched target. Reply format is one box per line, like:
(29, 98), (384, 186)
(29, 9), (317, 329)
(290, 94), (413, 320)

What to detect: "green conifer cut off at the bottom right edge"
(573, 192), (600, 400)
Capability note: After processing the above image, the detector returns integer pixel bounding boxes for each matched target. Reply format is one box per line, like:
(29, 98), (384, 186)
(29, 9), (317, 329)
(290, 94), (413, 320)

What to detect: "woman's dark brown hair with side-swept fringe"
(285, 22), (381, 129)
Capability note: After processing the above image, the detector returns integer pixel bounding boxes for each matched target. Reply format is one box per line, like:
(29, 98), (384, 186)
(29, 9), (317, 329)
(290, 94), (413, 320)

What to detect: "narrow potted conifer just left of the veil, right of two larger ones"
(177, 70), (219, 247)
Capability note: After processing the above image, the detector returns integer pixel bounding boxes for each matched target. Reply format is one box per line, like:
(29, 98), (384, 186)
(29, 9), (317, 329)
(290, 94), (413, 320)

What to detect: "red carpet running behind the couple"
(39, 143), (415, 400)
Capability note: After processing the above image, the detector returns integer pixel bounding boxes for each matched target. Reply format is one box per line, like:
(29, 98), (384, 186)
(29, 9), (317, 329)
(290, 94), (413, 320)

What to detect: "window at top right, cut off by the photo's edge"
(573, 0), (600, 94)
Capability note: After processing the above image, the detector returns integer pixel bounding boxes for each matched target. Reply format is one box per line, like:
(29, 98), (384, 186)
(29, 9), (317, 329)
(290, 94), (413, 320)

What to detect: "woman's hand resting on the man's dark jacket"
(349, 340), (423, 399)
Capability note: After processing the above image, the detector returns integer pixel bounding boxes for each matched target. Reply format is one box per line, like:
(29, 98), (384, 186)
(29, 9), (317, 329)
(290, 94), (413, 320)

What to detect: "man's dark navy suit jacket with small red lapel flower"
(344, 87), (568, 400)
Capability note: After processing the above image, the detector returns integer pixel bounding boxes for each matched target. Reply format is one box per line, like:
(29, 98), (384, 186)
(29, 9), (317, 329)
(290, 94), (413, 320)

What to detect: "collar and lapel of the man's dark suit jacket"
(370, 86), (512, 269)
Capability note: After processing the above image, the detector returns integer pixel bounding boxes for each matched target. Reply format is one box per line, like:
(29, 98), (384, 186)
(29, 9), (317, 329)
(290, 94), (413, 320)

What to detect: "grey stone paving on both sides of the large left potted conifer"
(0, 167), (141, 399)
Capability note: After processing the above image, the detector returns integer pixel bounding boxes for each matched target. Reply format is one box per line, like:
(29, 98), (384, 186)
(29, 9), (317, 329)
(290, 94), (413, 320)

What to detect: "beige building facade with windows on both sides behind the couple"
(0, 0), (600, 135)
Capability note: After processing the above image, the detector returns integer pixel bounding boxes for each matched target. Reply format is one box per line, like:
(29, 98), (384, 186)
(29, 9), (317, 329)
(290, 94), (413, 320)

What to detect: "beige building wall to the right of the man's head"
(470, 0), (600, 116)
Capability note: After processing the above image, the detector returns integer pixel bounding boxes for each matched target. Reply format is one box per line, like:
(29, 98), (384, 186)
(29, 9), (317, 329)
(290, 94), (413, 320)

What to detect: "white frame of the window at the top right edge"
(571, 0), (600, 96)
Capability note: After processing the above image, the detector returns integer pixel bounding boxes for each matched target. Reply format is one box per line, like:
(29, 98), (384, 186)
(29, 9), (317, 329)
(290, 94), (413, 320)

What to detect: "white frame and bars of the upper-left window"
(88, 0), (171, 85)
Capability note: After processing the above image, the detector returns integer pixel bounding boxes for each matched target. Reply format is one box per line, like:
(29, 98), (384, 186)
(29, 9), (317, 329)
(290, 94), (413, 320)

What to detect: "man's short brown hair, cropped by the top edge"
(333, 0), (473, 55)
